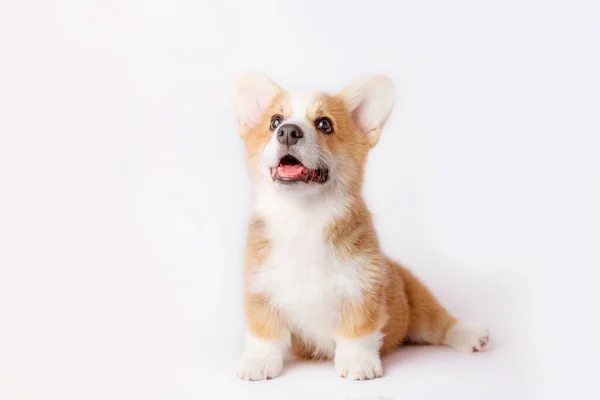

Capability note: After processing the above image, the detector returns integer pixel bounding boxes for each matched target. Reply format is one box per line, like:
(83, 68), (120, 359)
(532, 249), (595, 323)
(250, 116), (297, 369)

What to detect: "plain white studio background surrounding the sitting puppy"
(0, 0), (600, 400)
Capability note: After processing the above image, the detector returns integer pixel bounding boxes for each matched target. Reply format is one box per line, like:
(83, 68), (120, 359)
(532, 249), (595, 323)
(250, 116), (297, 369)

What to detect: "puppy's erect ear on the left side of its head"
(235, 71), (281, 134)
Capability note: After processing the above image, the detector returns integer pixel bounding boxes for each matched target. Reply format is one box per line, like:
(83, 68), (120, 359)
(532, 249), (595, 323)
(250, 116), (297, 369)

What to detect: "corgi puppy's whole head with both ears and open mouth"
(236, 72), (394, 195)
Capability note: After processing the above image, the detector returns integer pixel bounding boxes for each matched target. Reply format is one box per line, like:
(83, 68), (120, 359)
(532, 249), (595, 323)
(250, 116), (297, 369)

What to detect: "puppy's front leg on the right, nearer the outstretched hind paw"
(334, 293), (384, 380)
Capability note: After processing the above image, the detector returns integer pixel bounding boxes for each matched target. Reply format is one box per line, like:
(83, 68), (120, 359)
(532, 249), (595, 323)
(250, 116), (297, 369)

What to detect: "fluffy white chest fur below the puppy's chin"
(252, 186), (361, 352)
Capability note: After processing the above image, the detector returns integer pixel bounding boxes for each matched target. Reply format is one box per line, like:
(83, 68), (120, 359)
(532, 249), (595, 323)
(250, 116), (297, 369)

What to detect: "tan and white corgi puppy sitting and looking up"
(235, 72), (489, 380)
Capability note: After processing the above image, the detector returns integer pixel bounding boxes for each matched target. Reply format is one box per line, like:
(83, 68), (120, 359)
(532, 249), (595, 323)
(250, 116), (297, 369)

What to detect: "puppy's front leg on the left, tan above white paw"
(237, 294), (290, 381)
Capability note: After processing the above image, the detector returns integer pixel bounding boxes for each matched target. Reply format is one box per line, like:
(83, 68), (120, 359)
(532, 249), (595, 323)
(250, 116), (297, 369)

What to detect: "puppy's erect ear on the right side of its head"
(340, 76), (396, 147)
